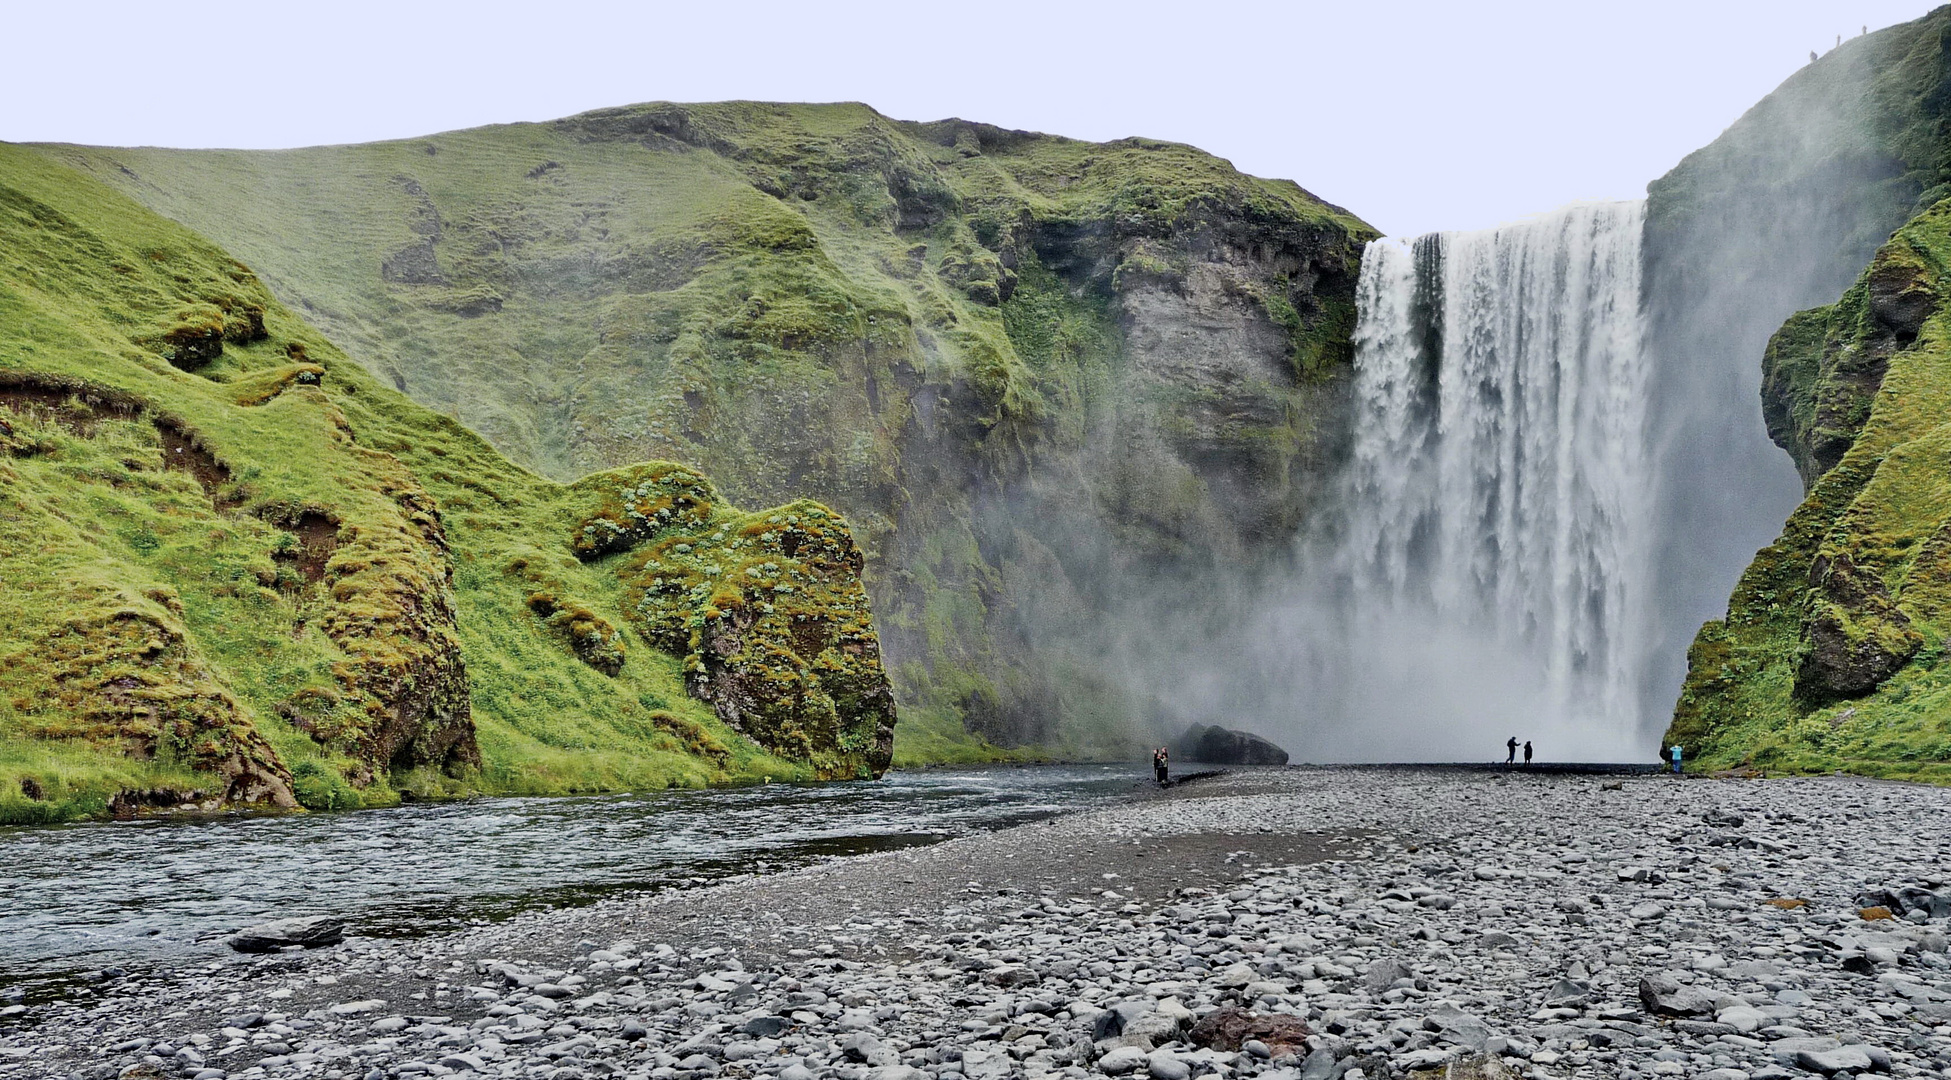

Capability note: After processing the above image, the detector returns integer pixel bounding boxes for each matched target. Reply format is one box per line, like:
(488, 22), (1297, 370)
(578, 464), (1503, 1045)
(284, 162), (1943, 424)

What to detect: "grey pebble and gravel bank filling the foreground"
(0, 768), (1951, 1080)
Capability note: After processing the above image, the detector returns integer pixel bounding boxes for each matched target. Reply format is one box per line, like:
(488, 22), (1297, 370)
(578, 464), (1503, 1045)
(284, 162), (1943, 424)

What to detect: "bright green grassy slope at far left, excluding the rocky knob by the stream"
(0, 146), (893, 821)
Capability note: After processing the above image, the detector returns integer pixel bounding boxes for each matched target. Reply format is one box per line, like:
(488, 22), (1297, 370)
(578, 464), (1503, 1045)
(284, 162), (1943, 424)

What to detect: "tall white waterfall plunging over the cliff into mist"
(1290, 203), (1656, 760)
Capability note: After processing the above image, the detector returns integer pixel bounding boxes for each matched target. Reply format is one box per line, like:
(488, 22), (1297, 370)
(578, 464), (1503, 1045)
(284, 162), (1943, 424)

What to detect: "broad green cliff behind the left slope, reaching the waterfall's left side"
(30, 103), (1374, 752)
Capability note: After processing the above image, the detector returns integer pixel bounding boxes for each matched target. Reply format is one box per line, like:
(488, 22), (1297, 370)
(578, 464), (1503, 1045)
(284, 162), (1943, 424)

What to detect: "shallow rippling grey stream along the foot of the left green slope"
(0, 764), (1141, 984)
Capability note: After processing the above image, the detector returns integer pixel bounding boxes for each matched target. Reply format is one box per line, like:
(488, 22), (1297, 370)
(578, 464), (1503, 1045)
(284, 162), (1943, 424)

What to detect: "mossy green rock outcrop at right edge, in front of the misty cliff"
(1666, 203), (1951, 782)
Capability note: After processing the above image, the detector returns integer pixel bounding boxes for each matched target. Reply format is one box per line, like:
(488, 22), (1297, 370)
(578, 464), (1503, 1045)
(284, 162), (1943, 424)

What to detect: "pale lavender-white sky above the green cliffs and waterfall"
(0, 0), (1930, 236)
